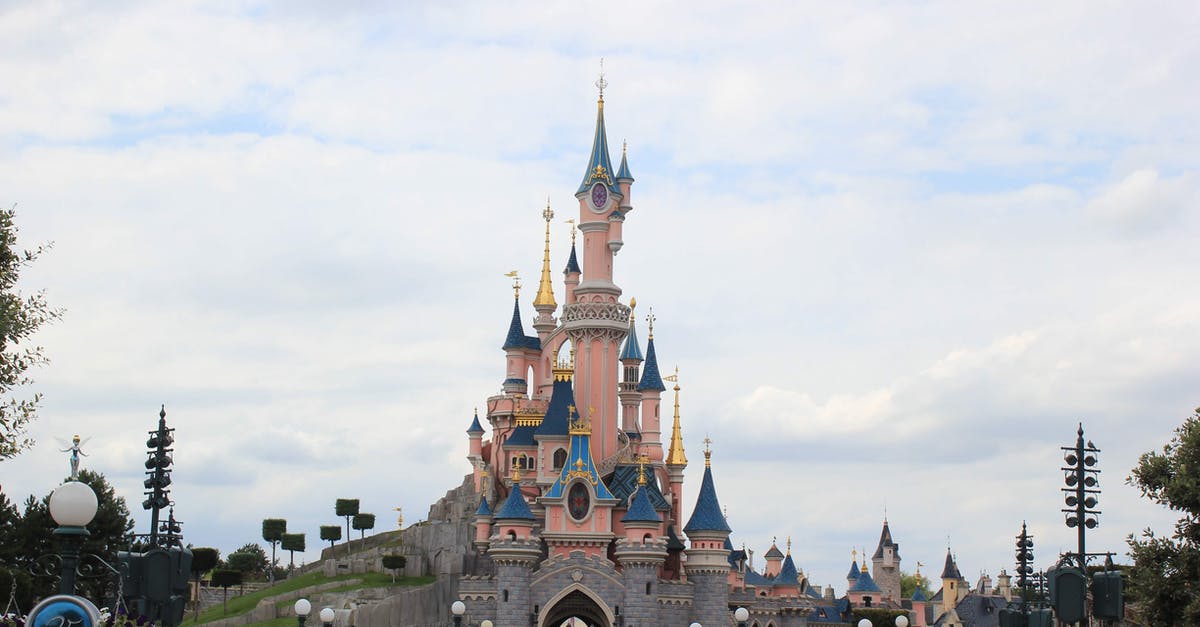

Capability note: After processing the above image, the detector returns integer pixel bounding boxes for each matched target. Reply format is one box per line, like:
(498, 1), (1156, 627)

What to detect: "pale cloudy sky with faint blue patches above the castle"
(0, 1), (1200, 593)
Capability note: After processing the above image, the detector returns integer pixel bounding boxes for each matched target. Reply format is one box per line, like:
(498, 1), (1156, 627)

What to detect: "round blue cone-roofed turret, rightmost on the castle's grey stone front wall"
(683, 438), (731, 625)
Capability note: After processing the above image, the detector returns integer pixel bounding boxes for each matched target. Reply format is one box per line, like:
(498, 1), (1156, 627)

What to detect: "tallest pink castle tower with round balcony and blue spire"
(560, 68), (634, 460)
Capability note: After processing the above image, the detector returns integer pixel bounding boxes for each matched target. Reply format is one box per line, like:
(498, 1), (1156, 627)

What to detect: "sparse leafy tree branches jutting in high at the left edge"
(0, 209), (62, 461)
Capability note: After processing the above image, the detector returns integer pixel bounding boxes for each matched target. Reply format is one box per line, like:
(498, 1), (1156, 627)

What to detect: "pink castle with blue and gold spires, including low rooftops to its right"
(457, 76), (1022, 627)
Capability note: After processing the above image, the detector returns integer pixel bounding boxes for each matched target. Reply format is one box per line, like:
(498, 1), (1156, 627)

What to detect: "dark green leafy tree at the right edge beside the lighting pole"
(1126, 408), (1200, 625)
